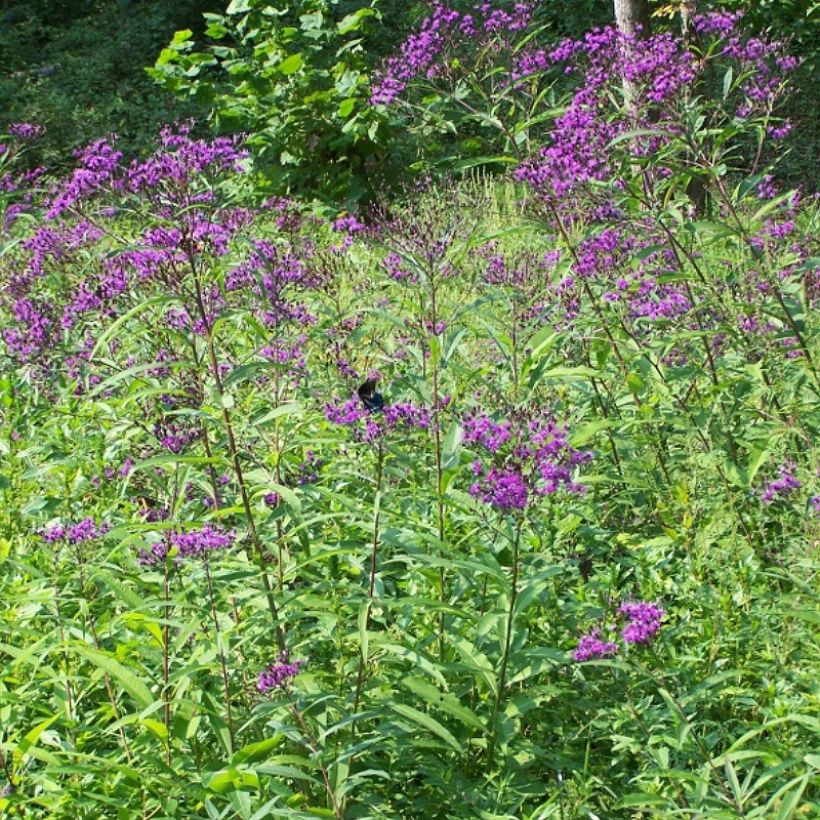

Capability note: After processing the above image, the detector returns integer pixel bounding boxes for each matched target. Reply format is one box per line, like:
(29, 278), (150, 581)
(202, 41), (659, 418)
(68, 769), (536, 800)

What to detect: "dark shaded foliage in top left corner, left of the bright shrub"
(0, 0), (217, 169)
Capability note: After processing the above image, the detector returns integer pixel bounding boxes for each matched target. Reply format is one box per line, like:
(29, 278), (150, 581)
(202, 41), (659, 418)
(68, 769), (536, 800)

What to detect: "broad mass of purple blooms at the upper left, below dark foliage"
(0, 125), (262, 370)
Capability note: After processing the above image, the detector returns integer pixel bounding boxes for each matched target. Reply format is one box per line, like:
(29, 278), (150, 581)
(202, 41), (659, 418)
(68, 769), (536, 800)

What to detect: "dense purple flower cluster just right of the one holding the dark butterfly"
(463, 412), (592, 511)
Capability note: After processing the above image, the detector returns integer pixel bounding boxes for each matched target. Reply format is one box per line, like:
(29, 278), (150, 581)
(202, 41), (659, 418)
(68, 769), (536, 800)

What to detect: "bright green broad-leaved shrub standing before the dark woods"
(150, 0), (414, 208)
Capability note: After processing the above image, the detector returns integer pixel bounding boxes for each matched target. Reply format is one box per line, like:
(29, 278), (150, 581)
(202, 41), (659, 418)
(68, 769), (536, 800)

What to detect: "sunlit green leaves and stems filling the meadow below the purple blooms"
(0, 113), (820, 820)
